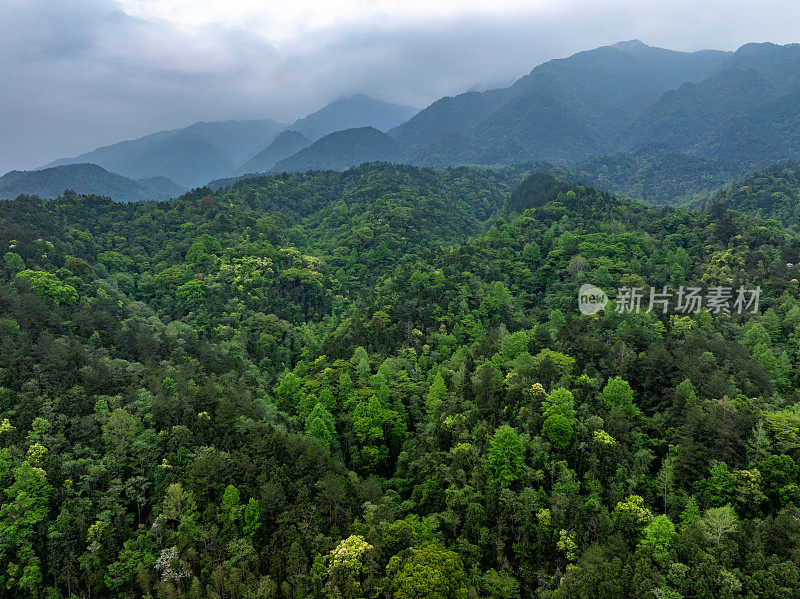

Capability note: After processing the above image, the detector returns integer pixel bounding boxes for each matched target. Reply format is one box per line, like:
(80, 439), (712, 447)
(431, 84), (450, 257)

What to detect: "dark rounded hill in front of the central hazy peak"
(272, 127), (401, 172)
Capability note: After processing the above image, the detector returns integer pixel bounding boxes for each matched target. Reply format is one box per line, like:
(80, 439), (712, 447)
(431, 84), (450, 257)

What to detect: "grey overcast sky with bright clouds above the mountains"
(0, 0), (800, 173)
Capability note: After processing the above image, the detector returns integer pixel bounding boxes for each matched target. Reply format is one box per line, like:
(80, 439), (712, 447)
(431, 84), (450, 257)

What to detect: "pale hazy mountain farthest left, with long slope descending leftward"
(47, 119), (284, 188)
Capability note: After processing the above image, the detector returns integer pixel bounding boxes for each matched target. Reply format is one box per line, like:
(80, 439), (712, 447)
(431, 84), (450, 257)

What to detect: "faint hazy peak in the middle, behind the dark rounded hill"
(289, 94), (417, 141)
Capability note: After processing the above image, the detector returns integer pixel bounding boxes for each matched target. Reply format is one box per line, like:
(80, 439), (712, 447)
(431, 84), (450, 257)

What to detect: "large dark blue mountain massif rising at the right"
(348, 41), (800, 172)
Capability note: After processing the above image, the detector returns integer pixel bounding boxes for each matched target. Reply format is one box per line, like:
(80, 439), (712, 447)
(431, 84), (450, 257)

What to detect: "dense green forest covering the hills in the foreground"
(0, 163), (800, 599)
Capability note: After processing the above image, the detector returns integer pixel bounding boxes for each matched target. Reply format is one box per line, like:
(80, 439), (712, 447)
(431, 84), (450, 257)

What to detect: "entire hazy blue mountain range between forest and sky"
(4, 41), (800, 203)
